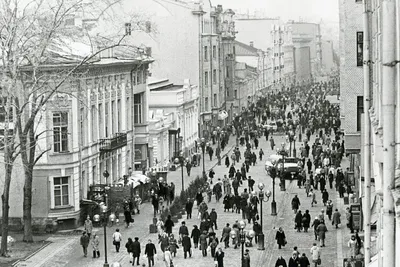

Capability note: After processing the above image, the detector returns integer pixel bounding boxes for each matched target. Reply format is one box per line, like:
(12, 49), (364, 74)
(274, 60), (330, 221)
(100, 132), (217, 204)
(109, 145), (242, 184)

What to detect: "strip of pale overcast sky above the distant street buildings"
(211, 0), (340, 22)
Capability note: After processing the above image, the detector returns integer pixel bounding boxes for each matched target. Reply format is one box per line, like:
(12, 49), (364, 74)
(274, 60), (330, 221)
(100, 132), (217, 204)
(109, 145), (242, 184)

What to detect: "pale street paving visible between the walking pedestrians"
(16, 136), (349, 267)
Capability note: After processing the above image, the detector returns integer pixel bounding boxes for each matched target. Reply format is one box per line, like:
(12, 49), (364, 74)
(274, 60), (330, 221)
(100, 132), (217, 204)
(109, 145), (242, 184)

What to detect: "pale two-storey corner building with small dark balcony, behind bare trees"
(0, 49), (152, 229)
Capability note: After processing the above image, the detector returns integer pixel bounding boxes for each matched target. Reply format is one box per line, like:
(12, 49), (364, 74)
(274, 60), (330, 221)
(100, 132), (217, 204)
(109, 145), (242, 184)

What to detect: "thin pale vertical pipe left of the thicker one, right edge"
(363, 0), (371, 266)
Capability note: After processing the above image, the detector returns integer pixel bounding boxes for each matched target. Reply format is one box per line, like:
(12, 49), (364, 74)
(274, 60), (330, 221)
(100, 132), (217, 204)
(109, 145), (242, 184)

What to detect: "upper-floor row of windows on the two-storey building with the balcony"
(53, 93), (144, 152)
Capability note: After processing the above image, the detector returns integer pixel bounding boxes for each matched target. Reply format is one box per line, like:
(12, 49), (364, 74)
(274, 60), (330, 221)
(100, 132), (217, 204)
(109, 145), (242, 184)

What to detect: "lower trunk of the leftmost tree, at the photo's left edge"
(0, 160), (13, 257)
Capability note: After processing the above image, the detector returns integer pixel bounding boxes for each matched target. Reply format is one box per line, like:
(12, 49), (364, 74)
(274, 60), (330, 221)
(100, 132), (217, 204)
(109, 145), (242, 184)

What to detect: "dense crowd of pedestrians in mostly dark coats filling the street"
(79, 78), (362, 267)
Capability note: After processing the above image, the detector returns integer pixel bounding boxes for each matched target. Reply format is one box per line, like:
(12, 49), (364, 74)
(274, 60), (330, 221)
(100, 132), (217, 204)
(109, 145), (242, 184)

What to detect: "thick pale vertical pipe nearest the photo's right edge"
(381, 0), (396, 266)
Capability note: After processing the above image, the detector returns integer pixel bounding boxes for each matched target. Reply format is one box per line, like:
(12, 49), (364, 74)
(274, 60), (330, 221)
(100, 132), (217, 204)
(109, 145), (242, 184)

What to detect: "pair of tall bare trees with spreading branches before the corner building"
(0, 0), (154, 253)
